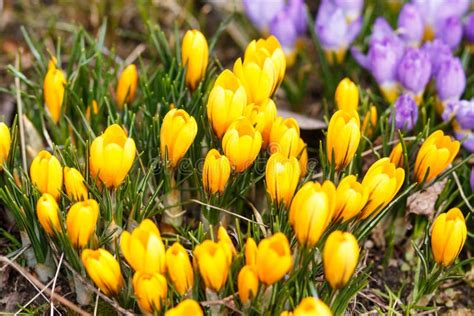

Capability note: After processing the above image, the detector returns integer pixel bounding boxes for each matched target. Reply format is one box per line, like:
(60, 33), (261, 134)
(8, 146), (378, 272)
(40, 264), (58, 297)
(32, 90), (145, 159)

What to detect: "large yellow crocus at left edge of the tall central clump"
(207, 69), (247, 139)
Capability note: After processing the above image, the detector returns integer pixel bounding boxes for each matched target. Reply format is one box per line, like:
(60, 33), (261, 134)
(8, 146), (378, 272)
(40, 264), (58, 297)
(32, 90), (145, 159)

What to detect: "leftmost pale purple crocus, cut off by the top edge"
(243, 0), (285, 32)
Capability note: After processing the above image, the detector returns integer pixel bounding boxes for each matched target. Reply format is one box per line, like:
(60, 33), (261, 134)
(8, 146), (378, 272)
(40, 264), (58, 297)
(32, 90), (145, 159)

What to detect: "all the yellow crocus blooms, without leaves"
(0, 30), (467, 315)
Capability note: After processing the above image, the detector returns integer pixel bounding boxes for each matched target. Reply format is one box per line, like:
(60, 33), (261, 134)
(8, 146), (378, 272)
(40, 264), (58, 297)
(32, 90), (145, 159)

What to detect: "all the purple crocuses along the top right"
(243, 0), (474, 152)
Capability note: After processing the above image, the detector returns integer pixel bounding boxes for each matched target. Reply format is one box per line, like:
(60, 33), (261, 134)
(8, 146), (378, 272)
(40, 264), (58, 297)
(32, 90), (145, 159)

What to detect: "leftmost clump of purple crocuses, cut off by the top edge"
(243, 0), (307, 56)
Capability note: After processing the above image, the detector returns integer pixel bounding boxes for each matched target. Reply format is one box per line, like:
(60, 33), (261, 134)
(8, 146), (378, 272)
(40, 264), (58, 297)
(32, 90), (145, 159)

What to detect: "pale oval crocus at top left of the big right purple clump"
(398, 3), (425, 46)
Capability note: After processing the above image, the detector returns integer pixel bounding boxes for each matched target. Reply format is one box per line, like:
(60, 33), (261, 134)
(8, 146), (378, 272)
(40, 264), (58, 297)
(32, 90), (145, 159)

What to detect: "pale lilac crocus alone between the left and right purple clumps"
(314, 0), (362, 55)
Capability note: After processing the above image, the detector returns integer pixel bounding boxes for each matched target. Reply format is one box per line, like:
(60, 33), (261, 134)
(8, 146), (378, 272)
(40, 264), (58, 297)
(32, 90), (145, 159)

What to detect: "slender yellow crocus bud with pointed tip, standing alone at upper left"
(43, 57), (66, 124)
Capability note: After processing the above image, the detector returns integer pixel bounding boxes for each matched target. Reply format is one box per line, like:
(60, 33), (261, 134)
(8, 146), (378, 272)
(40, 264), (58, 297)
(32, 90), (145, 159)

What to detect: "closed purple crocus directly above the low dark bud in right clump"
(397, 48), (431, 96)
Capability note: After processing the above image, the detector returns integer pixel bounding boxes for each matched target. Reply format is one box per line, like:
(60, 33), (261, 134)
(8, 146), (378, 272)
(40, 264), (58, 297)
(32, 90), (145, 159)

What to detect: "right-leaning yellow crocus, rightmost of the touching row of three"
(361, 158), (405, 219)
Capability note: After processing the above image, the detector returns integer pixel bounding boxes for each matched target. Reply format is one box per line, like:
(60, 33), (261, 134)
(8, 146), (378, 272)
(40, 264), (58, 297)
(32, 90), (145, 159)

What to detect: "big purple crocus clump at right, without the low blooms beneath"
(352, 1), (468, 105)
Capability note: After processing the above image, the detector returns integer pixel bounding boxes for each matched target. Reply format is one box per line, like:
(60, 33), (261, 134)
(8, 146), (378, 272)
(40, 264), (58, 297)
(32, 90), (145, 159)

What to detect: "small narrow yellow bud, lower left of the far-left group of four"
(36, 193), (61, 236)
